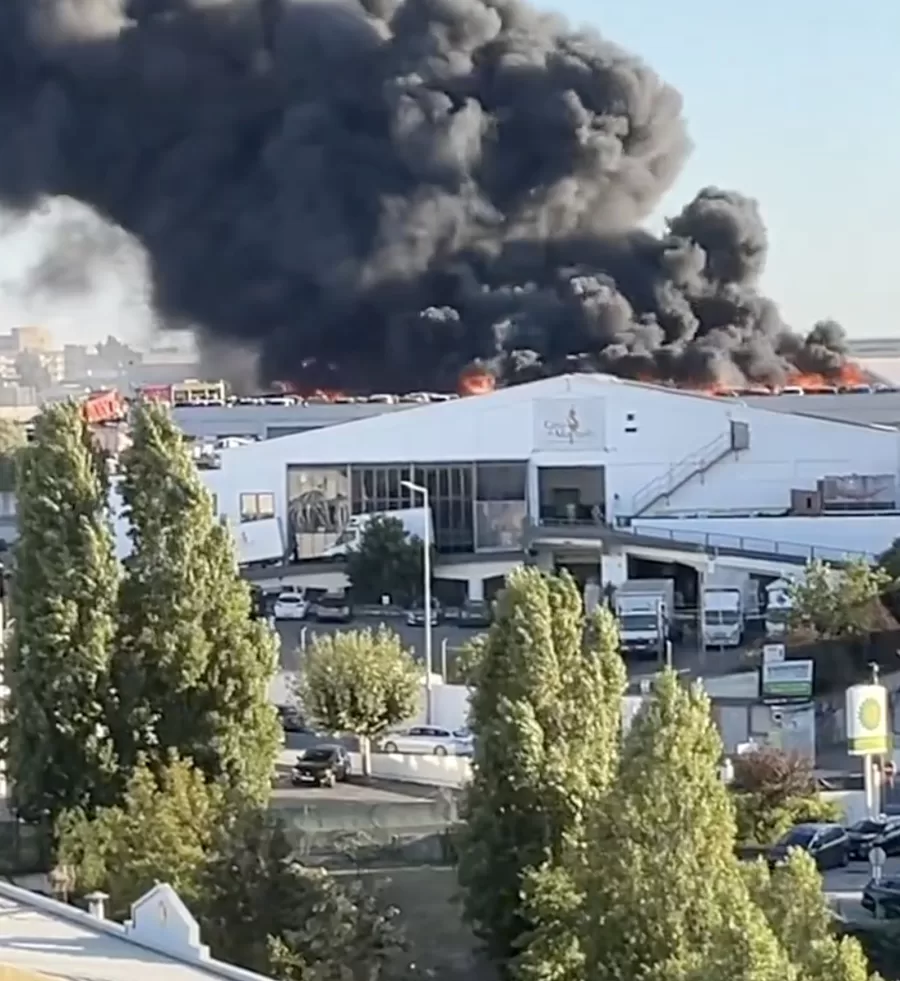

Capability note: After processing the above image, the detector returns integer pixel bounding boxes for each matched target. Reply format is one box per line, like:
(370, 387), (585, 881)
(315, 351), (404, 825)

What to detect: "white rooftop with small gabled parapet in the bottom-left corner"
(0, 884), (266, 981)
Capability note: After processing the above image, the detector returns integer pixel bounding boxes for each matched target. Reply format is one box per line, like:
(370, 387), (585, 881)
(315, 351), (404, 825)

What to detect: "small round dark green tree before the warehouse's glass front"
(347, 515), (434, 605)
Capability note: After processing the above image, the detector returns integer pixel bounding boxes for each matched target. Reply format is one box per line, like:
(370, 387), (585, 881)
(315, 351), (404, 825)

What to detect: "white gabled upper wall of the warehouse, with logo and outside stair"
(197, 375), (900, 544)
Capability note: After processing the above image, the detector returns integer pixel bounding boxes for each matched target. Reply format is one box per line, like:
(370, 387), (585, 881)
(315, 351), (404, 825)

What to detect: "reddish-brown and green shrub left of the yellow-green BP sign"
(730, 747), (840, 845)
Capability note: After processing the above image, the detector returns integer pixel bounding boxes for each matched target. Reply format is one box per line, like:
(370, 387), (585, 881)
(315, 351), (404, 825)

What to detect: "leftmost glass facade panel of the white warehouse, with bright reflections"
(287, 466), (351, 559)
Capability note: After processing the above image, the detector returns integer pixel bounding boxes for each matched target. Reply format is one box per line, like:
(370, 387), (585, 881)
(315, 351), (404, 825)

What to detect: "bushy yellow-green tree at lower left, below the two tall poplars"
(57, 757), (227, 918)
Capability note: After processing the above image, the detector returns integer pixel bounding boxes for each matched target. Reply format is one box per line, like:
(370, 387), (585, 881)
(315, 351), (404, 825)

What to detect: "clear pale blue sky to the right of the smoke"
(539, 0), (900, 337)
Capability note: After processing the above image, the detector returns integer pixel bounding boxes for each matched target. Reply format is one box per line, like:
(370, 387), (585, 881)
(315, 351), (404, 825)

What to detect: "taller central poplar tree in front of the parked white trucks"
(459, 568), (625, 977)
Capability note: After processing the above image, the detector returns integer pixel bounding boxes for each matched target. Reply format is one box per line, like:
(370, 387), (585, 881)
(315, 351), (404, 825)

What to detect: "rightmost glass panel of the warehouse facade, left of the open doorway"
(475, 462), (528, 551)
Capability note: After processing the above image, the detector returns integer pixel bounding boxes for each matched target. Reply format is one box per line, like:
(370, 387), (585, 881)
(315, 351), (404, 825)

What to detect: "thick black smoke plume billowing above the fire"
(0, 0), (844, 389)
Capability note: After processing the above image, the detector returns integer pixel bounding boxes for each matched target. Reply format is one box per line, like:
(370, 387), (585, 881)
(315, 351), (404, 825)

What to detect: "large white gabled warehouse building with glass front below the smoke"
(193, 374), (900, 599)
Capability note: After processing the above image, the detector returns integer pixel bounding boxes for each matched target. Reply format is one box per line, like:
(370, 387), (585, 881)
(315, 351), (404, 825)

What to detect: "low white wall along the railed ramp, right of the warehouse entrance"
(634, 514), (900, 561)
